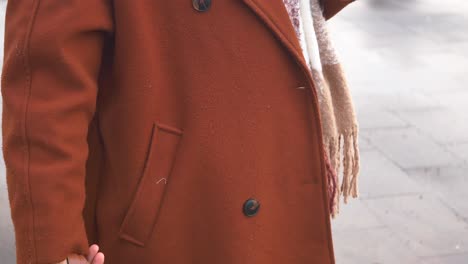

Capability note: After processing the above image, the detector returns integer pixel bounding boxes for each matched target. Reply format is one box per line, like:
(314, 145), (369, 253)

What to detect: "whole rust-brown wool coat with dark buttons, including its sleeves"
(2, 0), (350, 264)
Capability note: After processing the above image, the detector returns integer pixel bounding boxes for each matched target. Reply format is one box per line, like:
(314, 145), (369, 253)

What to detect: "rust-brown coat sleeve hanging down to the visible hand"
(0, 0), (114, 264)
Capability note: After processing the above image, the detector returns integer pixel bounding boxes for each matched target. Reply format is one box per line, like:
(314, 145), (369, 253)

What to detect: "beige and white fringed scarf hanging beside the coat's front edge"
(283, 0), (359, 218)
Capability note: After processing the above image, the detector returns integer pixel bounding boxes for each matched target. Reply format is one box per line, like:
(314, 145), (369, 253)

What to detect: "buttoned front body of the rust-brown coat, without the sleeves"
(84, 0), (333, 264)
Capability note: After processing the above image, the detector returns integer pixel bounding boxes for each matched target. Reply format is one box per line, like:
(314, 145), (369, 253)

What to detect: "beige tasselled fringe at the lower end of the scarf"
(326, 127), (360, 218)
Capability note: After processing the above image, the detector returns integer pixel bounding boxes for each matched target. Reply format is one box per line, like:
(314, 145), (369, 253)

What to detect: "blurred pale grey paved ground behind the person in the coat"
(0, 0), (468, 264)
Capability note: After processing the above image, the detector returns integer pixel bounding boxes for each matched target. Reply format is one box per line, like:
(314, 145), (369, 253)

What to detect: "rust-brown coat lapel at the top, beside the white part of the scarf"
(241, 0), (312, 80)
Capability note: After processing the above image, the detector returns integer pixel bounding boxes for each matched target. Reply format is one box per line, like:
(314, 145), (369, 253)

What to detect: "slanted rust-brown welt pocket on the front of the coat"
(119, 122), (183, 247)
